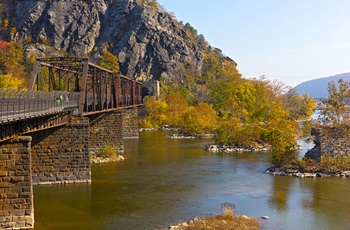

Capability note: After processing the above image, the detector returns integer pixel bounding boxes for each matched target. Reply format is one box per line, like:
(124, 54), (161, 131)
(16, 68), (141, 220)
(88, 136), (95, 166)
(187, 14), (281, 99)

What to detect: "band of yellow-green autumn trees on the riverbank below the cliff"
(140, 39), (316, 165)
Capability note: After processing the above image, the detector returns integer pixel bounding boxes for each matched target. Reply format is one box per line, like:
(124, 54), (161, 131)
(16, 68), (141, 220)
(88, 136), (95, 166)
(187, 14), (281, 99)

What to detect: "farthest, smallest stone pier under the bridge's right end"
(122, 108), (139, 138)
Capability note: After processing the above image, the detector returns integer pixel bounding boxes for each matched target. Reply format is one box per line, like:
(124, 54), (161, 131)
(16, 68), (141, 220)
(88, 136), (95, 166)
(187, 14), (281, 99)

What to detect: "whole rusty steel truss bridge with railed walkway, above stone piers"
(0, 57), (142, 141)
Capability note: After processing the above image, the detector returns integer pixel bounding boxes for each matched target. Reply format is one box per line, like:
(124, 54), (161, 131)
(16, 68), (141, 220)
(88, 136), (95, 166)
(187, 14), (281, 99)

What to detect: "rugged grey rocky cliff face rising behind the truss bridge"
(4, 0), (204, 84)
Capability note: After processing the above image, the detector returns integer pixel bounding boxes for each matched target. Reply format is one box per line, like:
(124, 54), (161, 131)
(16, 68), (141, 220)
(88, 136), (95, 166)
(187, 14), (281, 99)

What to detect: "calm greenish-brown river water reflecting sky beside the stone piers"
(34, 131), (350, 230)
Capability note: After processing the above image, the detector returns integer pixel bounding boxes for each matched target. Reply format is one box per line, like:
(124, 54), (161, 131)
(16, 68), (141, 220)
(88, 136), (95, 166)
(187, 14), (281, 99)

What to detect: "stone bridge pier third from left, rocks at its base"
(89, 110), (124, 153)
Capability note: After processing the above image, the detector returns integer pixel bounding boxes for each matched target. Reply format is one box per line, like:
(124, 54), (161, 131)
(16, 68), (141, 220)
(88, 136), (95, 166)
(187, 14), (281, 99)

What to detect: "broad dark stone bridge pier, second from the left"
(31, 117), (91, 184)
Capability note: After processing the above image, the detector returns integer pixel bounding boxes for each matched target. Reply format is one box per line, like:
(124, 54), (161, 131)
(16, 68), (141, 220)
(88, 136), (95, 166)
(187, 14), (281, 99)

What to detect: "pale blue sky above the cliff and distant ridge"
(158, 0), (350, 86)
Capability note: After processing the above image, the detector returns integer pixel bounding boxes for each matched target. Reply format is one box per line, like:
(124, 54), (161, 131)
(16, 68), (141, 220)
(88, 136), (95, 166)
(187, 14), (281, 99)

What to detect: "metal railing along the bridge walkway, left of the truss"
(0, 89), (79, 123)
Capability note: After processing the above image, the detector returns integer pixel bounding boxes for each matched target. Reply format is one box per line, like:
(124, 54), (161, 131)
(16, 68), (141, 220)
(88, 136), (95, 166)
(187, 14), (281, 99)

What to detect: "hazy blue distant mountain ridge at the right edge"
(294, 72), (350, 98)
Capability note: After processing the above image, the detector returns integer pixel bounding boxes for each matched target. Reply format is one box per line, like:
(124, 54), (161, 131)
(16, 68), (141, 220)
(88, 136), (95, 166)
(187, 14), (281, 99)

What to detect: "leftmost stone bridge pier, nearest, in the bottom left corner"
(0, 137), (34, 229)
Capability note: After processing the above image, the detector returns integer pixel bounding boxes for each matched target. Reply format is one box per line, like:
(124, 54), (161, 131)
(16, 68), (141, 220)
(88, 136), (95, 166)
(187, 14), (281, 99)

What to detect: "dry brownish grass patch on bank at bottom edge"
(176, 203), (260, 230)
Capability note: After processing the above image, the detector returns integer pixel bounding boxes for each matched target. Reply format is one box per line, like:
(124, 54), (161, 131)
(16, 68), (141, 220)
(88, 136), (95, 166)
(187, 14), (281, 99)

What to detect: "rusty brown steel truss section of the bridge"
(28, 57), (142, 116)
